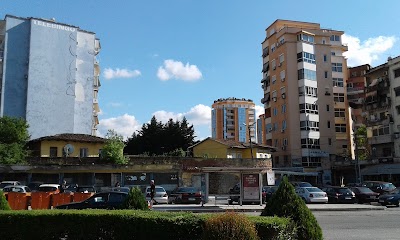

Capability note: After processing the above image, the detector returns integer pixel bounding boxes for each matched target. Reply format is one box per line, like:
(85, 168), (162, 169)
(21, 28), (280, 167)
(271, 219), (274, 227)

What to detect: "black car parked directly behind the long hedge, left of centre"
(55, 191), (128, 209)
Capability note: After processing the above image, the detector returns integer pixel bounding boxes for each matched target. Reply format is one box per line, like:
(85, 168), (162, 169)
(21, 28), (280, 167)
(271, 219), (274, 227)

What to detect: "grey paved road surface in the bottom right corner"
(313, 208), (400, 240)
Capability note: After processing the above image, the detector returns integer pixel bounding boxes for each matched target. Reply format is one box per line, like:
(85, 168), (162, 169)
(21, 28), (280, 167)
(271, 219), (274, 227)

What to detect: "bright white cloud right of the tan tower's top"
(342, 34), (397, 67)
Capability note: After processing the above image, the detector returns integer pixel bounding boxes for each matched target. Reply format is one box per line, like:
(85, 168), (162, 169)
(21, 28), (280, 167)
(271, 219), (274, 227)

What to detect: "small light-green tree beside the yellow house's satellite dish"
(101, 130), (128, 164)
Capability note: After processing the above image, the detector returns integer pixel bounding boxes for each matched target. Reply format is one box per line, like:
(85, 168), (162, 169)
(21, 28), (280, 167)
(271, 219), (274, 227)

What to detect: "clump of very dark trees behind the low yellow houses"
(124, 116), (196, 156)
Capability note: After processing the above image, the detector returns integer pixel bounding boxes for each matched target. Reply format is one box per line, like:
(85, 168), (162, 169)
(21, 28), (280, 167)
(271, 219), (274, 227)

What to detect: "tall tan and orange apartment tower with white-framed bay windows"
(261, 20), (349, 183)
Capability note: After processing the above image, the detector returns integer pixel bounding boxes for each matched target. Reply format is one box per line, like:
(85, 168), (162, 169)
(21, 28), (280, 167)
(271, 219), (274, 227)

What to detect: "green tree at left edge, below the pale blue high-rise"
(0, 117), (30, 164)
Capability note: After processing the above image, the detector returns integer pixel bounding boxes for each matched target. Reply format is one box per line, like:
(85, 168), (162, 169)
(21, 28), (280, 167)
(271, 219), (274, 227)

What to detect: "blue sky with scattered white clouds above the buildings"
(0, 0), (400, 140)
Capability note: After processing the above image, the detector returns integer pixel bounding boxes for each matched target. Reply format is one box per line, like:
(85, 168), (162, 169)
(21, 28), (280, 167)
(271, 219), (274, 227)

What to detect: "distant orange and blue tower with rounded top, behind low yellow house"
(211, 98), (256, 142)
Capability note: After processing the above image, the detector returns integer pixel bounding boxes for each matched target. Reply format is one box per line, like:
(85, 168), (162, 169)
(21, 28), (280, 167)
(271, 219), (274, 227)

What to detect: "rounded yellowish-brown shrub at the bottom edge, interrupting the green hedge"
(204, 212), (259, 240)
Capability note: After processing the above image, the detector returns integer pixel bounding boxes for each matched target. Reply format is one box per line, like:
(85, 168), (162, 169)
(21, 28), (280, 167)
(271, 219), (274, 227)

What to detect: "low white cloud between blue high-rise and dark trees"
(97, 114), (142, 139)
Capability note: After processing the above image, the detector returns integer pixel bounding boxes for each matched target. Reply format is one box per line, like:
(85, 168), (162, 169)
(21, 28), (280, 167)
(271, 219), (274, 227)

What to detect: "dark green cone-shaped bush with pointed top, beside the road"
(261, 177), (323, 240)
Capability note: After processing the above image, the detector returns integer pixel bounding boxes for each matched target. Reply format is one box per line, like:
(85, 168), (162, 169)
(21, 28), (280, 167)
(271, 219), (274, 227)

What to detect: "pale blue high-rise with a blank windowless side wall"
(0, 15), (100, 139)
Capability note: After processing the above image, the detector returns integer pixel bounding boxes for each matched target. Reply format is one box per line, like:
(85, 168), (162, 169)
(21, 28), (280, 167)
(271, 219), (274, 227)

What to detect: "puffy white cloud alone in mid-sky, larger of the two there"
(157, 59), (203, 82)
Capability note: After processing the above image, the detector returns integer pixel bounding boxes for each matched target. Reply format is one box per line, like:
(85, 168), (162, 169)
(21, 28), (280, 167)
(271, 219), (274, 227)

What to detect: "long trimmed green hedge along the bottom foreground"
(0, 210), (296, 240)
